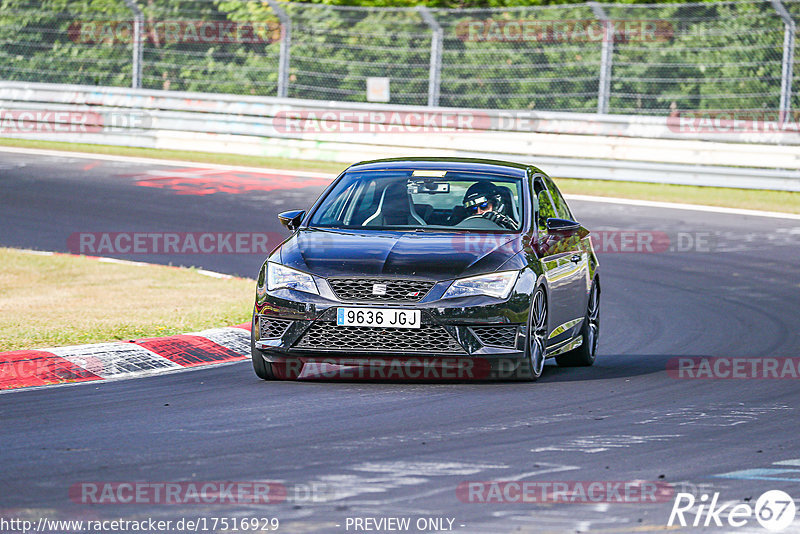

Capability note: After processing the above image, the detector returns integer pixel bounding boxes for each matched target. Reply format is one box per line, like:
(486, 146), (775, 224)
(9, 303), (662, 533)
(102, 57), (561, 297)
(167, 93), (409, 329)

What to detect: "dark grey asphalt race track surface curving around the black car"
(0, 149), (800, 533)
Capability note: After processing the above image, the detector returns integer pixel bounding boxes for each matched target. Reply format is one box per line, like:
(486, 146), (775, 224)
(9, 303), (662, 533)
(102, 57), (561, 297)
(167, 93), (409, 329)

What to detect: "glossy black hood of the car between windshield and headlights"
(280, 229), (522, 281)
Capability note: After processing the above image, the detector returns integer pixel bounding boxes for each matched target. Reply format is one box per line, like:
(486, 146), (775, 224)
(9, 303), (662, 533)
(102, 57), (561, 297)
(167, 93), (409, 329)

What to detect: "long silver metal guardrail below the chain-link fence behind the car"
(0, 82), (800, 191)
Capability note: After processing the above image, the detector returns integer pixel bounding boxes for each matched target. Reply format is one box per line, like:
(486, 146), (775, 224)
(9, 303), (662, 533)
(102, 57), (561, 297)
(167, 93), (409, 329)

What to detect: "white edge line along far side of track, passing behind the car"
(0, 146), (800, 220)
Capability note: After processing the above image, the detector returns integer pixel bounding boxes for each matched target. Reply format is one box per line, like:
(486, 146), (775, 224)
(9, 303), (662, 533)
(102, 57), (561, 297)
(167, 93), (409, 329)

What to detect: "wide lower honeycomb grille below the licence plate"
(295, 322), (464, 354)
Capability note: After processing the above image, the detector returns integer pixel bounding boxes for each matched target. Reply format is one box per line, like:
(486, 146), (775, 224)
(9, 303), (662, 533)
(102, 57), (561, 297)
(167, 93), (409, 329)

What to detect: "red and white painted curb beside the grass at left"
(0, 323), (250, 390)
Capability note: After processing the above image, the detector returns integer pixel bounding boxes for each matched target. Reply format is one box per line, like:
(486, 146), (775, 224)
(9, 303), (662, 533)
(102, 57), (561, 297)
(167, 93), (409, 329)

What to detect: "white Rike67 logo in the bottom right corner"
(667, 490), (797, 532)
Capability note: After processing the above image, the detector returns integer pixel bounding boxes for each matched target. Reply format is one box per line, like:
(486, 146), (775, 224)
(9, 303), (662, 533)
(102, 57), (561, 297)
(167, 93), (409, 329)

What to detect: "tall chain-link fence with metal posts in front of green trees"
(0, 0), (800, 114)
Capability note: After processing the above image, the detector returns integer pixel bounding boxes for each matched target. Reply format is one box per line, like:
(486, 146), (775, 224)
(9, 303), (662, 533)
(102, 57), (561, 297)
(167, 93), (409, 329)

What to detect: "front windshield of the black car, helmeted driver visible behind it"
(309, 170), (523, 232)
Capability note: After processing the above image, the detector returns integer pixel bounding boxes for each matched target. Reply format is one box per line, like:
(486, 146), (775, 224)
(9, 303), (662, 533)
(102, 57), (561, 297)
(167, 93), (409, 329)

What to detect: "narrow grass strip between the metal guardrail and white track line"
(0, 138), (800, 213)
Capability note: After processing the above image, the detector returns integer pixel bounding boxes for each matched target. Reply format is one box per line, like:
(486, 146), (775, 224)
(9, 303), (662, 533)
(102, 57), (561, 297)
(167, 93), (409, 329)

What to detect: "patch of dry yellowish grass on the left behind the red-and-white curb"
(0, 248), (255, 352)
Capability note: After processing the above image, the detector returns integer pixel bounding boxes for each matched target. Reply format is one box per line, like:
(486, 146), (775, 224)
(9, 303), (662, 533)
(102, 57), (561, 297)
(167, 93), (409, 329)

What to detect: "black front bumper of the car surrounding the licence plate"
(253, 276), (530, 378)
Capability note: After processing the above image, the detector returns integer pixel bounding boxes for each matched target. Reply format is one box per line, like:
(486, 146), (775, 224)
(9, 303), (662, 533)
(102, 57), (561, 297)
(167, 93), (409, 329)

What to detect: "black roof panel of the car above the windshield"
(347, 157), (538, 177)
